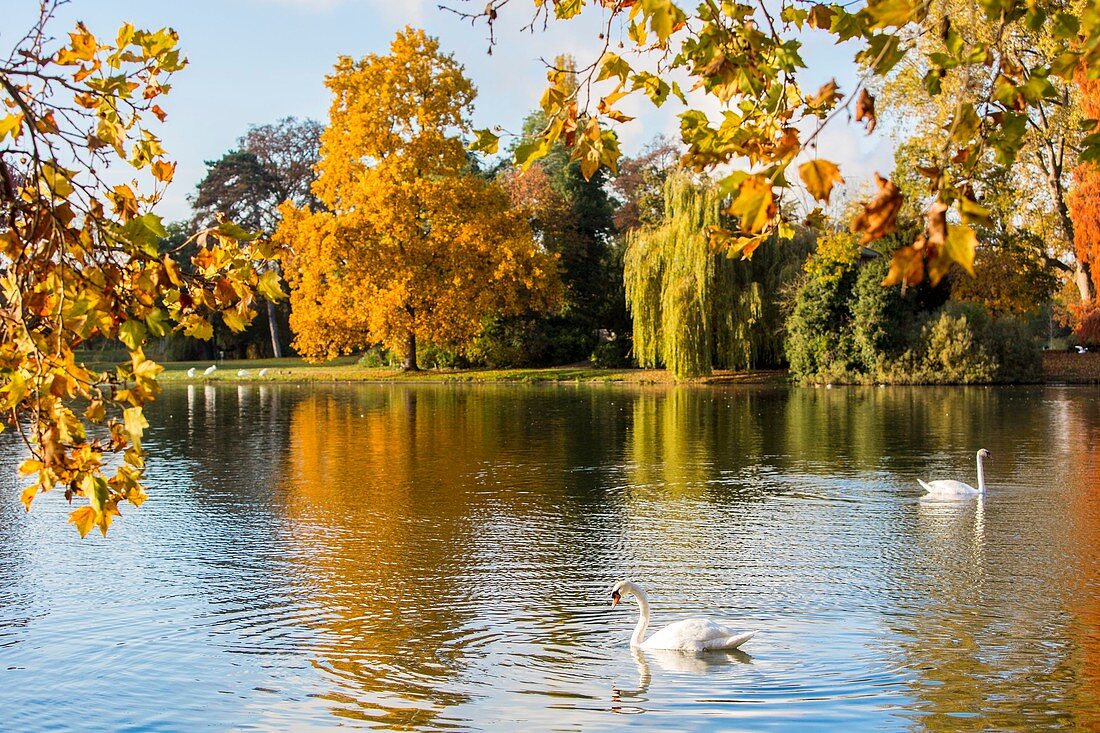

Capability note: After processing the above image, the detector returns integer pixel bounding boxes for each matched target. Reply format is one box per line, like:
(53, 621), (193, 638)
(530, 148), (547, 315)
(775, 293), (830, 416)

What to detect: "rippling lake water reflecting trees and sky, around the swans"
(0, 378), (1100, 731)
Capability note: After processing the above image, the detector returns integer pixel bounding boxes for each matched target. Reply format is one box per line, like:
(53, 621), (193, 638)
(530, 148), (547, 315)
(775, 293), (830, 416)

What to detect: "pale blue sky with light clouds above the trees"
(0, 0), (892, 219)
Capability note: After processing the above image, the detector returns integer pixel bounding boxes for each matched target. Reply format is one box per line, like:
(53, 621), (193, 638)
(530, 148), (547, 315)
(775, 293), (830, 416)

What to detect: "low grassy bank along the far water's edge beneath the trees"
(161, 357), (787, 384)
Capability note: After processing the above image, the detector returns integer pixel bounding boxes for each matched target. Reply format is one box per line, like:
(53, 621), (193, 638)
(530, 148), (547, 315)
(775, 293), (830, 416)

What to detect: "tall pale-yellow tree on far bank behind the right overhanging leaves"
(879, 0), (1095, 301)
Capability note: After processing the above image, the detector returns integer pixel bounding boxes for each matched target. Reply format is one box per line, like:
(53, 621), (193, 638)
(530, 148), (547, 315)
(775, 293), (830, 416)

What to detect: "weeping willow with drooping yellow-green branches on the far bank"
(624, 173), (812, 380)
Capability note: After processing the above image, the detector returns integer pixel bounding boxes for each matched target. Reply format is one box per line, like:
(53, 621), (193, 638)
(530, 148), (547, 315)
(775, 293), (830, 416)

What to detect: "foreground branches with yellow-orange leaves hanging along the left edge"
(0, 2), (278, 536)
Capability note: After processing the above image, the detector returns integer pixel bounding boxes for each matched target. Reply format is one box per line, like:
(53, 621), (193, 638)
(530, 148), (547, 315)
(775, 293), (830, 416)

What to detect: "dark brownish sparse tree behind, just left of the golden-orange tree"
(191, 117), (321, 358)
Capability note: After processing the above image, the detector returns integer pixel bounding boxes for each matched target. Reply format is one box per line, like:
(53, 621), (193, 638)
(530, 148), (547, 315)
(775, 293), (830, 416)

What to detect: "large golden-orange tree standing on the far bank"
(277, 29), (560, 369)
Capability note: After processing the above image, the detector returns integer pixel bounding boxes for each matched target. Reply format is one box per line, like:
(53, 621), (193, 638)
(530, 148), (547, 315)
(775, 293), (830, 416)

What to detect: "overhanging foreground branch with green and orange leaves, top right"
(459, 0), (1100, 294)
